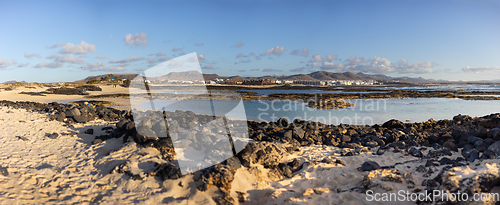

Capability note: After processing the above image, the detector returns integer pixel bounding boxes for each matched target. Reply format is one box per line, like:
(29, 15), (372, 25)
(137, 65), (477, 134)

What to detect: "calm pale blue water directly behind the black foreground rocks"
(141, 98), (500, 125)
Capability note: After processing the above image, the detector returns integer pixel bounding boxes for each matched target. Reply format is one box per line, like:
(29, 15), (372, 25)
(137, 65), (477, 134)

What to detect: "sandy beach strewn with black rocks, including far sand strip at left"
(0, 86), (500, 204)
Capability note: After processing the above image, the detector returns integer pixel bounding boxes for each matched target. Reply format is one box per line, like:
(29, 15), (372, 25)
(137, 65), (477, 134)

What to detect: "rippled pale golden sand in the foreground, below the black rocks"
(0, 107), (500, 205)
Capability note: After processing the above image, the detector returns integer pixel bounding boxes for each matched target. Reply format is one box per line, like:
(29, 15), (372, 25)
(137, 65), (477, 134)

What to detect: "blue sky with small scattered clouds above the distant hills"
(0, 0), (500, 82)
